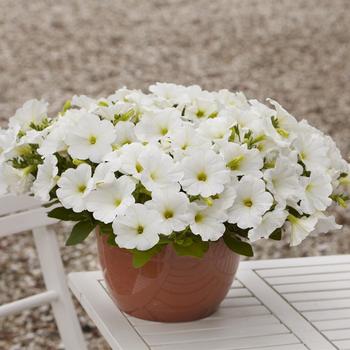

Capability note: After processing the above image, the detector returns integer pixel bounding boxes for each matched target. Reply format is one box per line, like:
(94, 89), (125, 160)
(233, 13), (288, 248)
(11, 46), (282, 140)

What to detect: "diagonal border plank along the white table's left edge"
(68, 272), (149, 350)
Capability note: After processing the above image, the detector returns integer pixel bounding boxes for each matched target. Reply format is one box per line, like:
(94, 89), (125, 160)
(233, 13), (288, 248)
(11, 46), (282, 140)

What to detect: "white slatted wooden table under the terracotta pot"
(69, 255), (350, 350)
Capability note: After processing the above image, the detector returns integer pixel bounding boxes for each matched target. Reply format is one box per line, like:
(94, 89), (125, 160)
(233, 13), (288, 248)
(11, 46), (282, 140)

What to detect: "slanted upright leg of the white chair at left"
(33, 227), (86, 350)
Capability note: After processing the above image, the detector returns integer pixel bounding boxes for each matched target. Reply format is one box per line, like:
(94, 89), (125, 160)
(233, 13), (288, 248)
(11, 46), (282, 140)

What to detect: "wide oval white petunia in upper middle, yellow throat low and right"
(135, 108), (181, 142)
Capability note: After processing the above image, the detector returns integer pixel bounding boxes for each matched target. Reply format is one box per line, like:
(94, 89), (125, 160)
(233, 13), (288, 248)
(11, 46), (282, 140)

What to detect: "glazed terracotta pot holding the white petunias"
(97, 233), (239, 322)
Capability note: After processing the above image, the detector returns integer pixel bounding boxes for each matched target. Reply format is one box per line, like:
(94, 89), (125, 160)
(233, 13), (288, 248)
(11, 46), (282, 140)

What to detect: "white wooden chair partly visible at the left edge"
(0, 196), (86, 350)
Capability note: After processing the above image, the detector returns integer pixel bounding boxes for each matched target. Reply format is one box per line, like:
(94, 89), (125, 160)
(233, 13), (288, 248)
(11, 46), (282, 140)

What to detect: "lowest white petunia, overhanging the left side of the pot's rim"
(113, 203), (163, 250)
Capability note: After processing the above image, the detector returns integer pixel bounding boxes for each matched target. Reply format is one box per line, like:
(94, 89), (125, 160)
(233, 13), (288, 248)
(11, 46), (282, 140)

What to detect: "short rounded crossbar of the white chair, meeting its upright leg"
(0, 290), (58, 317)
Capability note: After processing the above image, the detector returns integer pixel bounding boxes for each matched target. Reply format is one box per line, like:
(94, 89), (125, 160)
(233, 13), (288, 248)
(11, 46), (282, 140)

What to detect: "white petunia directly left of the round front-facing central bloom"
(139, 147), (183, 191)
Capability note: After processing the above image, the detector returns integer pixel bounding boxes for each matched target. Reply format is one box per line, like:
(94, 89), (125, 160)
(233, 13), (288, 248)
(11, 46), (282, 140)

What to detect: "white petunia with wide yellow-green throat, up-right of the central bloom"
(220, 142), (264, 177)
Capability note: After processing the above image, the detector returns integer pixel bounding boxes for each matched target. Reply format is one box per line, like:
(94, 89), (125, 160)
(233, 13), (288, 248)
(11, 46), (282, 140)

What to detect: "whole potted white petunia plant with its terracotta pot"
(0, 83), (349, 321)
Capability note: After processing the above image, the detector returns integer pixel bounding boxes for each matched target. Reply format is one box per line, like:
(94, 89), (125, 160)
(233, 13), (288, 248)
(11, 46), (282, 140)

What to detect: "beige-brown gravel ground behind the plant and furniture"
(0, 0), (350, 350)
